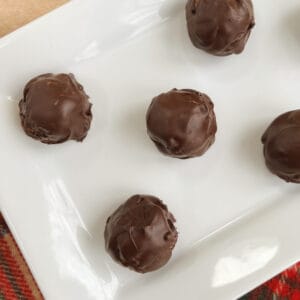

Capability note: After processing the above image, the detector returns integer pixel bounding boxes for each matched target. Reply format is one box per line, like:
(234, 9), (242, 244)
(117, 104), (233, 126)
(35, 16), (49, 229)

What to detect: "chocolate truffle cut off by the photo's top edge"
(186, 0), (255, 56)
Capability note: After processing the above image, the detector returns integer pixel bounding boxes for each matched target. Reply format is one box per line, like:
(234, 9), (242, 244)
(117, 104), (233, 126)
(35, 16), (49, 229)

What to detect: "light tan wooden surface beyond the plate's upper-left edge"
(0, 0), (69, 37)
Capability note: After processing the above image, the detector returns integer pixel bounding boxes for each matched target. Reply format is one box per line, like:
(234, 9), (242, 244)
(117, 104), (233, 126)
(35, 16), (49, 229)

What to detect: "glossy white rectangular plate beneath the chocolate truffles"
(0, 0), (300, 300)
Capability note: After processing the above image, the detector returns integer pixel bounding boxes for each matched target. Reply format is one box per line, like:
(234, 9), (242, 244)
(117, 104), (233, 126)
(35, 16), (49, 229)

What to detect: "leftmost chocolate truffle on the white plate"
(19, 73), (92, 144)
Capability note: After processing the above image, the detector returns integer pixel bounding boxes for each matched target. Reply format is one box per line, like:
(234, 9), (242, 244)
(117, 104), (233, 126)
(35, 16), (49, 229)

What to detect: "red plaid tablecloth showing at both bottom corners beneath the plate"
(0, 215), (300, 300)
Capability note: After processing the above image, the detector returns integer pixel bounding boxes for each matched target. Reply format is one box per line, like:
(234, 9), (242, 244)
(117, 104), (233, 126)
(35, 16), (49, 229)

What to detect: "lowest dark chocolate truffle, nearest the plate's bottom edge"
(104, 195), (178, 273)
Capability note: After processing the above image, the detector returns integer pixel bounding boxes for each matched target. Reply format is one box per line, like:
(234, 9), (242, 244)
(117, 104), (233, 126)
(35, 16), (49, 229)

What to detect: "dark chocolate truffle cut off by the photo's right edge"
(262, 110), (300, 183)
